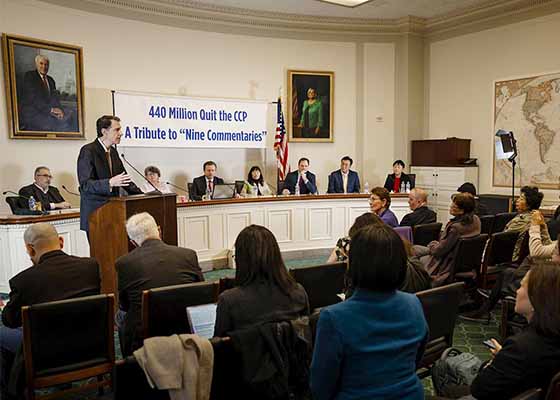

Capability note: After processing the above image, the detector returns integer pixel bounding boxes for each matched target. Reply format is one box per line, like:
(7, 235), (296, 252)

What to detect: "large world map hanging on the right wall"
(493, 73), (560, 189)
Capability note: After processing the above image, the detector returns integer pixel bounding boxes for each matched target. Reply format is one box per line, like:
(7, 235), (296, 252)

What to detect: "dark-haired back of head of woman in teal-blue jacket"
(348, 225), (407, 292)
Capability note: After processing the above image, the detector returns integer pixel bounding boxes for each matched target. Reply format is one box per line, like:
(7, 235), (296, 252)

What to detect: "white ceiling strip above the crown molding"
(186, 0), (496, 18)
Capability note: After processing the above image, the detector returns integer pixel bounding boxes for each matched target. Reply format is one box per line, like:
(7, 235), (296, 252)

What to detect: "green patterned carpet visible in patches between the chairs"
(0, 257), (499, 400)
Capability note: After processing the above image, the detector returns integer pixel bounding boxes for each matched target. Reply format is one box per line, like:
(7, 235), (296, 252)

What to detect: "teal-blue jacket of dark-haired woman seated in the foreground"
(311, 289), (428, 400)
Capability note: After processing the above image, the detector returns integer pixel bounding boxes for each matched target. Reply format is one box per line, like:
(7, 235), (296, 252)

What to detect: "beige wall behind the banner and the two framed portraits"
(0, 0), (402, 212)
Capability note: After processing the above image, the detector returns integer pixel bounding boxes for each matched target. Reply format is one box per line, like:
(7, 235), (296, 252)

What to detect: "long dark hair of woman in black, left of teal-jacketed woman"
(235, 225), (296, 294)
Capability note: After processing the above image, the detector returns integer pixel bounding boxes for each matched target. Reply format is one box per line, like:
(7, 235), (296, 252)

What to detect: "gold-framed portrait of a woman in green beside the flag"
(286, 70), (334, 143)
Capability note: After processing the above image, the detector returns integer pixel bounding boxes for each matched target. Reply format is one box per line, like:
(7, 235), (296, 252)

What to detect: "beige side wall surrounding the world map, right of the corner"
(425, 14), (560, 202)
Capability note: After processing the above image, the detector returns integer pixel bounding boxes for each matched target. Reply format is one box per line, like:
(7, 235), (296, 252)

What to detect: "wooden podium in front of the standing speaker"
(89, 193), (177, 294)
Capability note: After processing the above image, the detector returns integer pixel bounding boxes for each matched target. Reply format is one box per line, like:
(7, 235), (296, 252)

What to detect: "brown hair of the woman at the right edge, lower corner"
(527, 261), (560, 337)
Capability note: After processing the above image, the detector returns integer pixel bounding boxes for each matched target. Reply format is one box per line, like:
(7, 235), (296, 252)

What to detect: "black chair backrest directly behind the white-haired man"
(142, 282), (220, 339)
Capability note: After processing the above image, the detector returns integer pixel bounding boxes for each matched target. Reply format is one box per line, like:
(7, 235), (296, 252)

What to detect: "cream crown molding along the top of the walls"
(41, 0), (560, 41)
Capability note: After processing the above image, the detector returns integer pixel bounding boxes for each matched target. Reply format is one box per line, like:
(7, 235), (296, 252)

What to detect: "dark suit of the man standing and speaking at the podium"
(78, 139), (142, 232)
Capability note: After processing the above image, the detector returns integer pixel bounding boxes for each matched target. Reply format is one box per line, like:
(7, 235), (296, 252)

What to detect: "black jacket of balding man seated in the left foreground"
(2, 250), (101, 328)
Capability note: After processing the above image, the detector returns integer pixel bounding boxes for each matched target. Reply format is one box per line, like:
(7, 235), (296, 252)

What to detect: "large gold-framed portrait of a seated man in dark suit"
(2, 34), (85, 139)
